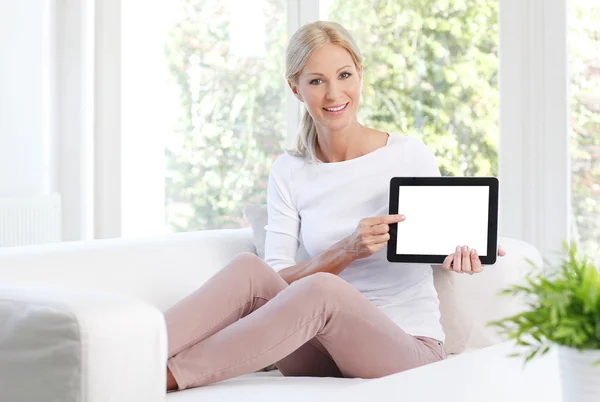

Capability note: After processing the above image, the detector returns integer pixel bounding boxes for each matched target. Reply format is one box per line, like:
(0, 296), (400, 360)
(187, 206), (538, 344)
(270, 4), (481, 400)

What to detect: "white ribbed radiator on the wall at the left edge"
(0, 195), (61, 247)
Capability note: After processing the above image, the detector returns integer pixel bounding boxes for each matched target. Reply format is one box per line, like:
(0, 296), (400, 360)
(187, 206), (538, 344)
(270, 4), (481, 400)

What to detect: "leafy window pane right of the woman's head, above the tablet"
(321, 0), (499, 176)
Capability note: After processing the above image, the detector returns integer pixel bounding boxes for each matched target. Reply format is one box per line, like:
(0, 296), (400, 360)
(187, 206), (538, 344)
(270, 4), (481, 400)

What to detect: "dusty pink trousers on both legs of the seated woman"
(165, 253), (446, 389)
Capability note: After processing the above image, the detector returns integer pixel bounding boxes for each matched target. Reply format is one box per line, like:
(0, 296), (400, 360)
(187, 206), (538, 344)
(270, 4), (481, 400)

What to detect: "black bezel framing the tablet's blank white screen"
(387, 177), (499, 265)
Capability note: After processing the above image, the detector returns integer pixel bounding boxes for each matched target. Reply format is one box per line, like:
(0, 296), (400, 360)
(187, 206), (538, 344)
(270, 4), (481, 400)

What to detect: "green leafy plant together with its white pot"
(489, 243), (600, 402)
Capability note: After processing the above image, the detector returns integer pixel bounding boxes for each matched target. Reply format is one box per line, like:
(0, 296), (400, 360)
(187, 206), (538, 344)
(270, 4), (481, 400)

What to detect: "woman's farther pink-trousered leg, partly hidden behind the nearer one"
(165, 253), (341, 389)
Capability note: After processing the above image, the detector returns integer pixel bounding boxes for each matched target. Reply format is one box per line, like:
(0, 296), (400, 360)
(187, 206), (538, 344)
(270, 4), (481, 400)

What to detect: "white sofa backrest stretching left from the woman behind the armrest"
(0, 228), (255, 311)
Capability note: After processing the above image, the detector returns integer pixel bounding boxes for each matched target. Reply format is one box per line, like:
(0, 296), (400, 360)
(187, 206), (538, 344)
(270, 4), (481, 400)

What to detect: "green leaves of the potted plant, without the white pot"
(489, 244), (600, 362)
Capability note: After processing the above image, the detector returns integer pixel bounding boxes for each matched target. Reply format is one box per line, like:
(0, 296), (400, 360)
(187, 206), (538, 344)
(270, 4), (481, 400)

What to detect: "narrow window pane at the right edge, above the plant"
(568, 0), (600, 264)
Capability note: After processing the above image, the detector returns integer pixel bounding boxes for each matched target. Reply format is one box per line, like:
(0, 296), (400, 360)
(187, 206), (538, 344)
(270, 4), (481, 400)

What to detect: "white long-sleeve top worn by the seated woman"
(265, 133), (445, 342)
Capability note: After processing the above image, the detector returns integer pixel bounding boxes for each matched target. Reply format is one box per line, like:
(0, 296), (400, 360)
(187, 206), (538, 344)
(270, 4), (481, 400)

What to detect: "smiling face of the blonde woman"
(288, 44), (362, 131)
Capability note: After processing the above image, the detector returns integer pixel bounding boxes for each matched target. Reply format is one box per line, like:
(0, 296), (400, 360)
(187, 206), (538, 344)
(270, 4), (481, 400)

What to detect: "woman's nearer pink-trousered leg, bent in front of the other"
(169, 266), (445, 389)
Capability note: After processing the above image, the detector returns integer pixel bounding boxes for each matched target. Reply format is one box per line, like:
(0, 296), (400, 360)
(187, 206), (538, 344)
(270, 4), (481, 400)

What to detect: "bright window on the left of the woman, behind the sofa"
(122, 0), (287, 235)
